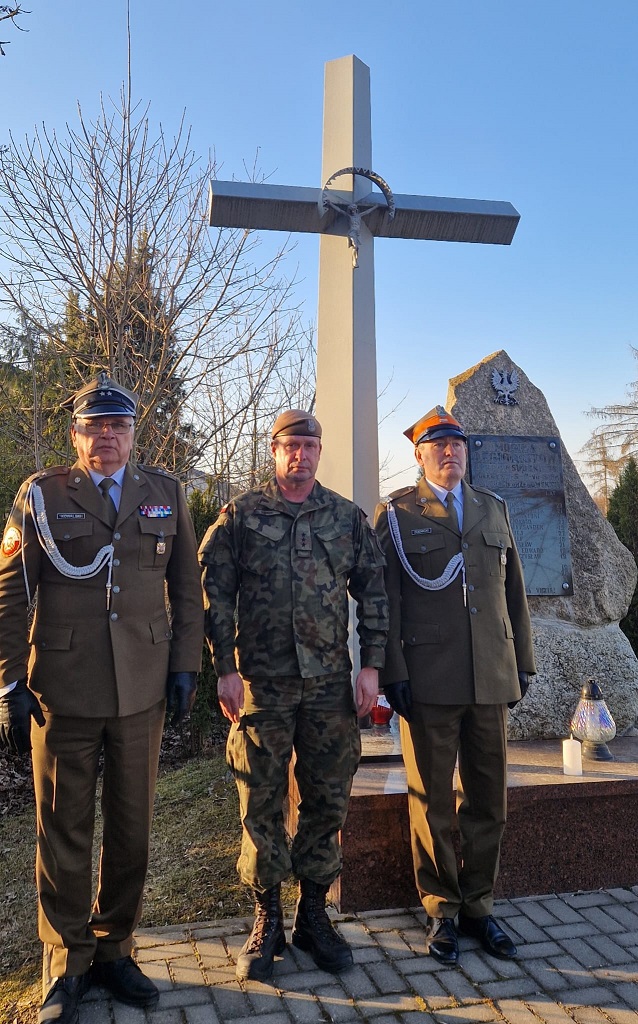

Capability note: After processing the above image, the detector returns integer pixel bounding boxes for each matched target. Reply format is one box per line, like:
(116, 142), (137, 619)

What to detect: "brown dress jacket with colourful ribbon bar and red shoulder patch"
(0, 463), (204, 718)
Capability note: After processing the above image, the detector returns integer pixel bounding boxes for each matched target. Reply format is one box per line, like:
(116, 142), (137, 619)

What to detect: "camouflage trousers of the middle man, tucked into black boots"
(226, 673), (360, 892)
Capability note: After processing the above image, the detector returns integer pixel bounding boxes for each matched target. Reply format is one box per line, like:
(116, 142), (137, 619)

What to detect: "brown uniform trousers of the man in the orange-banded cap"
(400, 702), (507, 918)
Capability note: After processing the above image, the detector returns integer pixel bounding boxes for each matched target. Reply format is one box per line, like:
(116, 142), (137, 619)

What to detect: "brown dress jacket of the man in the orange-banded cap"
(375, 478), (536, 705)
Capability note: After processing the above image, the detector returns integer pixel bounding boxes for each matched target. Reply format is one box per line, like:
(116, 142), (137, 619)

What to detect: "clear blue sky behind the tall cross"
(0, 0), (638, 486)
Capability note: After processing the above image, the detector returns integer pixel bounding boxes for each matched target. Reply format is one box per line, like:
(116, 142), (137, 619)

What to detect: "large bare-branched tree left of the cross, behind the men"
(0, 89), (312, 480)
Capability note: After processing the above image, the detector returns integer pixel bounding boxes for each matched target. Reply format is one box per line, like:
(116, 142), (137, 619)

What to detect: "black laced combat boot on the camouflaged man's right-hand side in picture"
(292, 879), (352, 974)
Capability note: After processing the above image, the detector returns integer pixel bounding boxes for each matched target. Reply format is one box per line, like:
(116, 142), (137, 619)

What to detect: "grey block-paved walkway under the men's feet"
(80, 886), (638, 1024)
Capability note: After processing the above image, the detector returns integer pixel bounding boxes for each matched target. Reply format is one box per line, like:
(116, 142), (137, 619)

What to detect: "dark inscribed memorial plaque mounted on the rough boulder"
(468, 434), (573, 597)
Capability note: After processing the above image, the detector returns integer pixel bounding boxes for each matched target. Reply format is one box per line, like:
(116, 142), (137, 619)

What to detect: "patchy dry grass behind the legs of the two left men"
(0, 754), (296, 1024)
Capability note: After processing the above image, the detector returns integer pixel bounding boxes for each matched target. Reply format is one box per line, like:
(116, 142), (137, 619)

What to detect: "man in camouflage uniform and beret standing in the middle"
(200, 410), (388, 980)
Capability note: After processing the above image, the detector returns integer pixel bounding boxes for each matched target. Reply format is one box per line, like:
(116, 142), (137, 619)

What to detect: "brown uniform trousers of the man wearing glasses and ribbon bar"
(31, 700), (166, 977)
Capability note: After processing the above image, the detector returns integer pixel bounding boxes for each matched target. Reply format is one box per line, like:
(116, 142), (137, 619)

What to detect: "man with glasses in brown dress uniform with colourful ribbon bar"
(0, 373), (204, 1024)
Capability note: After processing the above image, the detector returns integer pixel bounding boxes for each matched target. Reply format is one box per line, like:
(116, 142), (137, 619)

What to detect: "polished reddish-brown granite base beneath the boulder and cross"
(288, 736), (638, 913)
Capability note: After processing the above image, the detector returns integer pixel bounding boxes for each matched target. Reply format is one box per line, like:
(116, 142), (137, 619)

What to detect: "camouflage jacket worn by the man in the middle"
(200, 480), (388, 679)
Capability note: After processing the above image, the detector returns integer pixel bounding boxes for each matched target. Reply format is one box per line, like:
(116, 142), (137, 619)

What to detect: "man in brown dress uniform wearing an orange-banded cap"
(375, 406), (536, 964)
